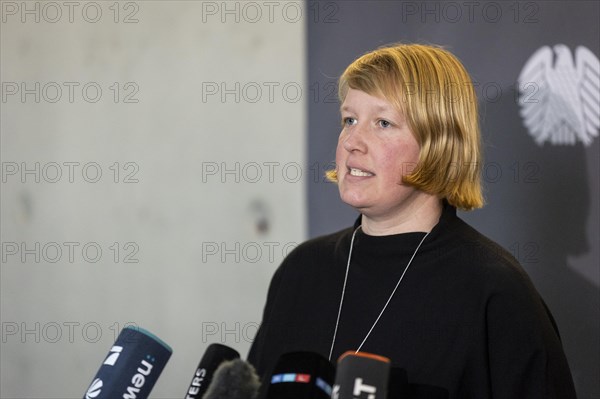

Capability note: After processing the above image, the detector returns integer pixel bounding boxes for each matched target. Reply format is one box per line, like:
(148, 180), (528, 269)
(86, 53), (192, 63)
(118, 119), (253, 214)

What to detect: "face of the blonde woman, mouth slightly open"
(336, 89), (424, 220)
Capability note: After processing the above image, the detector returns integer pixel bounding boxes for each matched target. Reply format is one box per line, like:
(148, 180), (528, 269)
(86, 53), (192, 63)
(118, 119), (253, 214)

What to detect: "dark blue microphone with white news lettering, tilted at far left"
(84, 327), (173, 399)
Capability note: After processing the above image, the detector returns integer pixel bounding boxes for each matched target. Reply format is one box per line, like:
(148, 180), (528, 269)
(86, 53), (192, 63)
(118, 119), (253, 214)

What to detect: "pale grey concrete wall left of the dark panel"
(0, 1), (306, 398)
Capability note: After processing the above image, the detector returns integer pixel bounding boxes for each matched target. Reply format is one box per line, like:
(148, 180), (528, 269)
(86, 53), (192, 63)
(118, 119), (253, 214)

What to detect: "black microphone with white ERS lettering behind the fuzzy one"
(185, 344), (240, 399)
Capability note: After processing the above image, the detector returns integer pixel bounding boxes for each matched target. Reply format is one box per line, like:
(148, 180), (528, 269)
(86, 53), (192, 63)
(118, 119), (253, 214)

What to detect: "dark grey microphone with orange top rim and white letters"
(331, 351), (391, 399)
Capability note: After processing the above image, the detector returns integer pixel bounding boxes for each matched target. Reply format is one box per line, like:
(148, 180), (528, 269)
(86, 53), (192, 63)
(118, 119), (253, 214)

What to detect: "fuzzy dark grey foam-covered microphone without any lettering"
(203, 359), (260, 399)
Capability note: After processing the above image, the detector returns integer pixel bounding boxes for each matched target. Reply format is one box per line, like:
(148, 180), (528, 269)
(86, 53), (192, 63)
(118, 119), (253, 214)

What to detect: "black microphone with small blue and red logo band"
(266, 352), (335, 399)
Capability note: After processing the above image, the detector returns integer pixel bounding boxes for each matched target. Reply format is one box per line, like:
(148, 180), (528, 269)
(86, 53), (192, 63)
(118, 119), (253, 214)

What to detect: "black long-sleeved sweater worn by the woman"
(248, 204), (575, 399)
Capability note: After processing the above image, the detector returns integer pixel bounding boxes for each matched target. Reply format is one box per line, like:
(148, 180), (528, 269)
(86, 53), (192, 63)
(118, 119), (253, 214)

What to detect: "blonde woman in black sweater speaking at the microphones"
(249, 45), (575, 399)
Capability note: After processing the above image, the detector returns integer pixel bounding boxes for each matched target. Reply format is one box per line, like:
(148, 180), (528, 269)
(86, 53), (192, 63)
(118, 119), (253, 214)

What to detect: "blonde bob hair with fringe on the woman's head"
(326, 44), (484, 210)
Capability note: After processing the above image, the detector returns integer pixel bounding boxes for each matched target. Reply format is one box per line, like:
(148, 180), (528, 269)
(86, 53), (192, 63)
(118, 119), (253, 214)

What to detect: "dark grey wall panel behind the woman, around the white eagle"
(307, 1), (600, 399)
